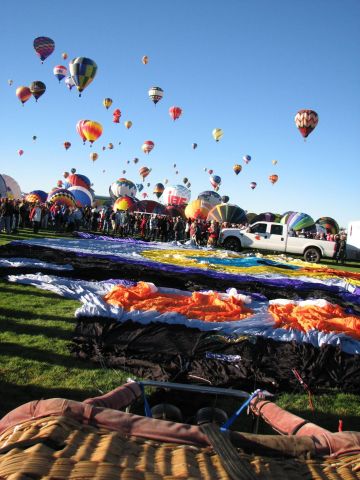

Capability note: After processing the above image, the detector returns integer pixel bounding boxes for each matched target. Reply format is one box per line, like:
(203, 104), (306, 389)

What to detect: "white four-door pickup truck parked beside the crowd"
(219, 222), (335, 262)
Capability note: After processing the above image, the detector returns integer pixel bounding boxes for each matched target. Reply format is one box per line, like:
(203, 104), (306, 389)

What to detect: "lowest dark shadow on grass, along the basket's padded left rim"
(0, 380), (100, 418)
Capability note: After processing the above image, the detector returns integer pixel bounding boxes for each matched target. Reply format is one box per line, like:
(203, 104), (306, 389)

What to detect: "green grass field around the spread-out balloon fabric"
(0, 231), (360, 431)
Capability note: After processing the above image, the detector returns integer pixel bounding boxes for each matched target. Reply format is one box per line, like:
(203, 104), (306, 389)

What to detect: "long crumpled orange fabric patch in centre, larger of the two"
(104, 282), (253, 322)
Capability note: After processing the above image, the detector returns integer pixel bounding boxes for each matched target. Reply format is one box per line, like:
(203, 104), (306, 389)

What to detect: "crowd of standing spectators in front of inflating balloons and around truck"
(0, 198), (346, 263)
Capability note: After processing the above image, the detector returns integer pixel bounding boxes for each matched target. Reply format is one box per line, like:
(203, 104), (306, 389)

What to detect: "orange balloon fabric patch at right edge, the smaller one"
(269, 303), (360, 340)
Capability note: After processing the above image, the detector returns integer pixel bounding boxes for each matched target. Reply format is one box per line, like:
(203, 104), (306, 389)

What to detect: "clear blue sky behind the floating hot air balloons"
(0, 0), (360, 226)
